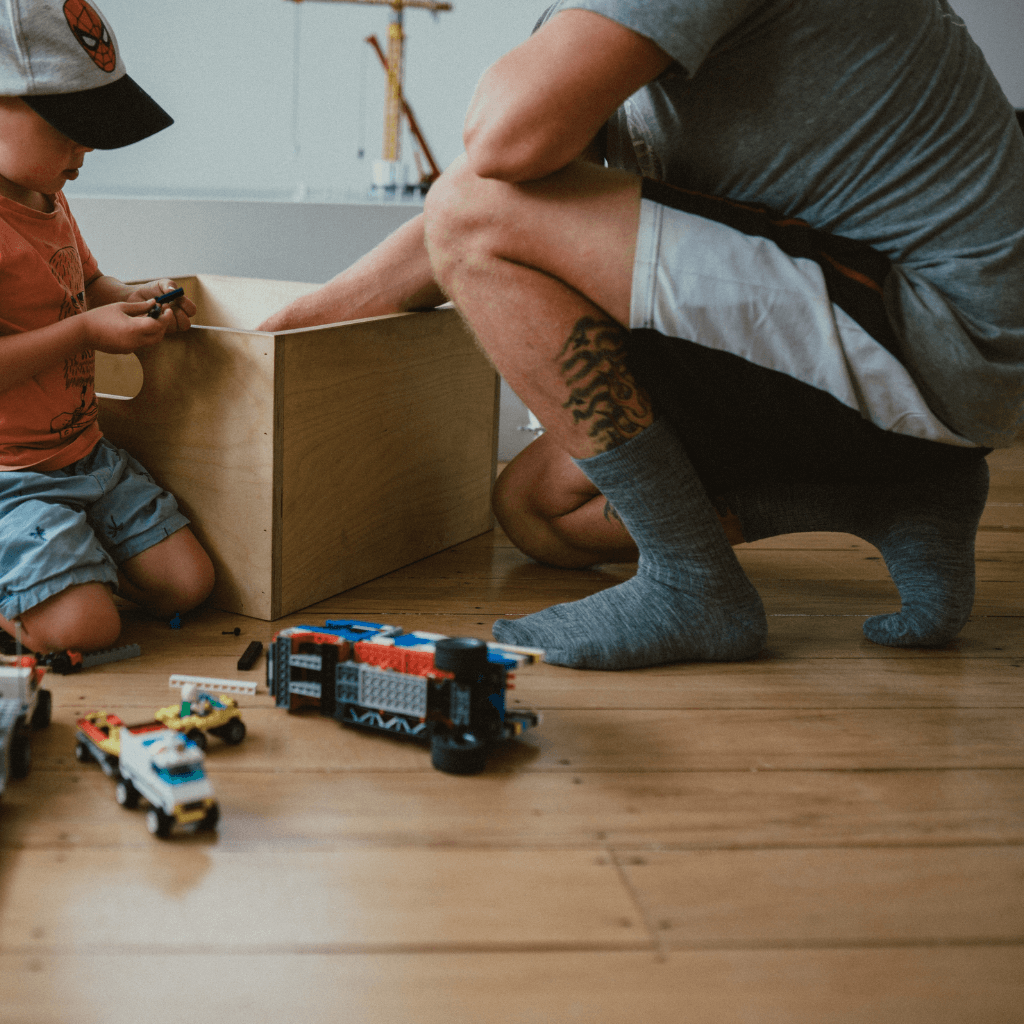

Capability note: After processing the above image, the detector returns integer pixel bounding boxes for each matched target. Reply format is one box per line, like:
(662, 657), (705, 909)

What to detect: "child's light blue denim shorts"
(0, 439), (188, 621)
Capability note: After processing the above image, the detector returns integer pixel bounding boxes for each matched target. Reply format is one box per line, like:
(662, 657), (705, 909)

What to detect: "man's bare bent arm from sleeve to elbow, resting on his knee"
(463, 9), (672, 181)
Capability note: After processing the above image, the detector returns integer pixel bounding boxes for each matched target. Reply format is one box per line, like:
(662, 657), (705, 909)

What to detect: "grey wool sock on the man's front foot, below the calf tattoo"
(494, 421), (768, 669)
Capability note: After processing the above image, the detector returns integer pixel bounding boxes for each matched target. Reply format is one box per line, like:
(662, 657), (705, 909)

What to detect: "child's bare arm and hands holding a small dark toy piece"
(0, 278), (196, 393)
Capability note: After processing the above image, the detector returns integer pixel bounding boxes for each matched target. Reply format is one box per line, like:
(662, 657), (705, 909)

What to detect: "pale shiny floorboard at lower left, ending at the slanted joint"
(3, 847), (653, 955)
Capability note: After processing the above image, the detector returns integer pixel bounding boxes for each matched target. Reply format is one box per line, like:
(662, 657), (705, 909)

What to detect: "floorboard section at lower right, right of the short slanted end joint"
(622, 846), (1024, 949)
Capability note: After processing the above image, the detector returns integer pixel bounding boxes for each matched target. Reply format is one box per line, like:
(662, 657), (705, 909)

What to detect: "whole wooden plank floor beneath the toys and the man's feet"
(0, 447), (1024, 1024)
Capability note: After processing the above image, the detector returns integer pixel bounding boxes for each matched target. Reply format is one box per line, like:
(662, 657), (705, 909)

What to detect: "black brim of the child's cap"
(22, 75), (174, 150)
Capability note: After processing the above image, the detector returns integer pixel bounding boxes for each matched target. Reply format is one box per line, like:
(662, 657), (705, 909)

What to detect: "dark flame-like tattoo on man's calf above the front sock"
(557, 316), (650, 452)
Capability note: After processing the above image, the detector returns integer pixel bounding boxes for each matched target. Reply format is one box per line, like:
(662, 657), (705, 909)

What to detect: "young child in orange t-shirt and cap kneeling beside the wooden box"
(0, 0), (213, 651)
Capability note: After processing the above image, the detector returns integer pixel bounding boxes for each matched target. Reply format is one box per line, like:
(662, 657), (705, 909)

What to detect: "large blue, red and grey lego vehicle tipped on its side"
(266, 618), (540, 775)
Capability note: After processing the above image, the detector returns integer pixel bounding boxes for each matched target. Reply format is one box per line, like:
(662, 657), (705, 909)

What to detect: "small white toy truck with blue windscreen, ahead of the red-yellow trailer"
(116, 722), (220, 839)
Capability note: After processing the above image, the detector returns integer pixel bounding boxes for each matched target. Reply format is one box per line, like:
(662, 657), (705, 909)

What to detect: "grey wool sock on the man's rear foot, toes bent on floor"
(725, 460), (988, 647)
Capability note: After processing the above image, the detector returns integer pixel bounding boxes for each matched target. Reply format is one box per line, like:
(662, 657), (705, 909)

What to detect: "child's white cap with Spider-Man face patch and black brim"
(0, 0), (174, 150)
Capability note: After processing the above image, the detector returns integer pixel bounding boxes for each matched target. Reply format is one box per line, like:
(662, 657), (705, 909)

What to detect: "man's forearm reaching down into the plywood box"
(259, 214), (447, 331)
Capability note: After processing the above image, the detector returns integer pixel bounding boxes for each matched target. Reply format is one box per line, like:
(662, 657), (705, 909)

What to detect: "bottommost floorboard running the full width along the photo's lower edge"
(0, 945), (1024, 1024)
